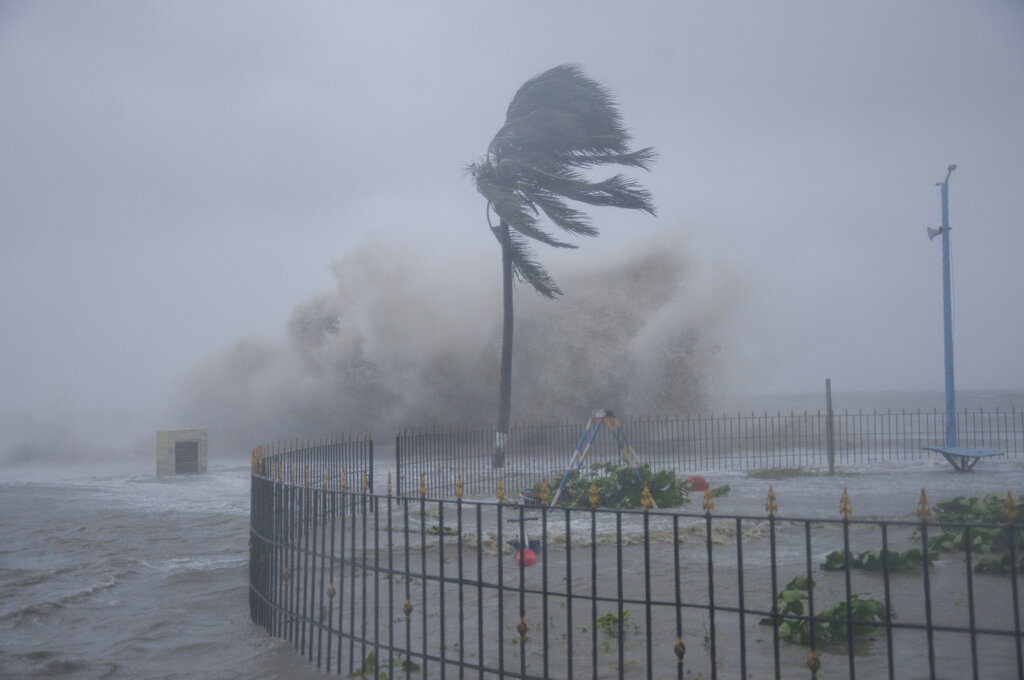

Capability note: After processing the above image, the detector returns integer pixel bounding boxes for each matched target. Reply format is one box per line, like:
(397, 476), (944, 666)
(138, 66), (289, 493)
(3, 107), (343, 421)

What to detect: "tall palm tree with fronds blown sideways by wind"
(467, 65), (655, 467)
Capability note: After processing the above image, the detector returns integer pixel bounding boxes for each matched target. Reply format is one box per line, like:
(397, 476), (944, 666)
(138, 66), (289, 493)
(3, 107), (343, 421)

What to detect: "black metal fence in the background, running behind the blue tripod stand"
(395, 409), (1024, 496)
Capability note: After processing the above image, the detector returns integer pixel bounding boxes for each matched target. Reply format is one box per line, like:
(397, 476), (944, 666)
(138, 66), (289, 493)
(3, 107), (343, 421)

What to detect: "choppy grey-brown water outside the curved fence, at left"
(0, 465), (323, 678)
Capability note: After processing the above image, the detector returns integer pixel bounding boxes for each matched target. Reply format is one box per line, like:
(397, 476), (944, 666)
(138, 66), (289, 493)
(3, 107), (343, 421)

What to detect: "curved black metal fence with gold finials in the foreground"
(250, 442), (1024, 680)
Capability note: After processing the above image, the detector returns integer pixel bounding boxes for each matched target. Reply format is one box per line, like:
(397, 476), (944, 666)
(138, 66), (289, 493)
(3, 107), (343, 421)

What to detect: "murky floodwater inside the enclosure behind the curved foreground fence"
(268, 450), (1024, 679)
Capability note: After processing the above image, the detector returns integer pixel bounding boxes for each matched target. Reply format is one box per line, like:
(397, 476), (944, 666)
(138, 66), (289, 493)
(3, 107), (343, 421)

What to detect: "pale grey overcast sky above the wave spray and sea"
(0, 0), (1024, 444)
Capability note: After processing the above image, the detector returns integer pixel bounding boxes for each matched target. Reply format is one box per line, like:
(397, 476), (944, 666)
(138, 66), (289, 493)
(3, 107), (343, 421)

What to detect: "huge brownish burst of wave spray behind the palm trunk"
(167, 235), (728, 453)
